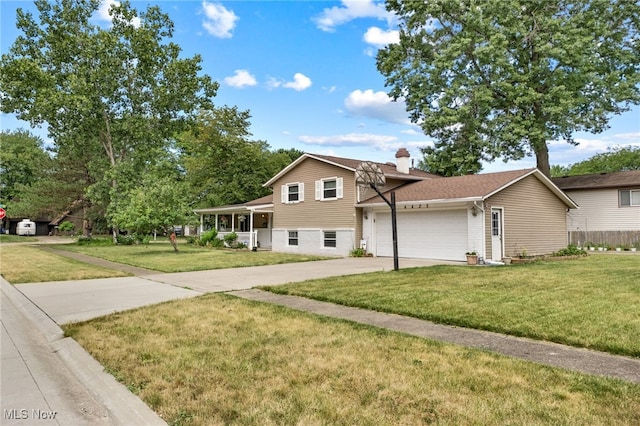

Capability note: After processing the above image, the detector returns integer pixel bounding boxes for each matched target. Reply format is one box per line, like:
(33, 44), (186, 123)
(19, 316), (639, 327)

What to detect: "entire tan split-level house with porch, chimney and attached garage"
(196, 149), (577, 261)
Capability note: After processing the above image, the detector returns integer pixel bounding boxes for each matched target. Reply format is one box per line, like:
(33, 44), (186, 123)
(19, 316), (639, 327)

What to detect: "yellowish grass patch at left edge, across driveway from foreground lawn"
(0, 244), (129, 284)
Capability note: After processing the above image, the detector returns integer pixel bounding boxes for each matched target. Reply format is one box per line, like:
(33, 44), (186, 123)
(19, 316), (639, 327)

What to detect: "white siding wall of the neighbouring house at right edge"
(565, 189), (640, 232)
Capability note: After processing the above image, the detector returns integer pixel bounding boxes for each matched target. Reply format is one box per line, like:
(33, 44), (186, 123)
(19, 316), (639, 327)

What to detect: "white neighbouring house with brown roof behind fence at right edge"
(553, 170), (640, 246)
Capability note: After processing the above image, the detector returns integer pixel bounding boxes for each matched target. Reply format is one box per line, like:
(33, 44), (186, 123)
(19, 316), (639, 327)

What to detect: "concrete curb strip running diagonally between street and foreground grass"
(0, 277), (167, 425)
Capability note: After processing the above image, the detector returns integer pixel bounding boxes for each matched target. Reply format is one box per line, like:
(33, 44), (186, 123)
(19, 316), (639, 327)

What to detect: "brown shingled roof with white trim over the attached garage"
(360, 169), (577, 208)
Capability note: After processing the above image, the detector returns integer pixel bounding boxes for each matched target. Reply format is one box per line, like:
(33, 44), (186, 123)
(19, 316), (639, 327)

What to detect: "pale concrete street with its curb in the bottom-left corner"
(0, 277), (166, 425)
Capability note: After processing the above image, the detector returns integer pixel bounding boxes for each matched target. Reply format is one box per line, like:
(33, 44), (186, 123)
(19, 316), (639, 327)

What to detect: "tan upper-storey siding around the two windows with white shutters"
(273, 158), (357, 229)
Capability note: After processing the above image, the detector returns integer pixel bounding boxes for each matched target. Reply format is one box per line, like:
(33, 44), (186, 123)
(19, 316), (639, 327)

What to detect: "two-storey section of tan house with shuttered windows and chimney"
(265, 149), (441, 256)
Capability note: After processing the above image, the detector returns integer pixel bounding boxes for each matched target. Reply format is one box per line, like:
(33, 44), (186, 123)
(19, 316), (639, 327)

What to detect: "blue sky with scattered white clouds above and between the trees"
(0, 0), (640, 172)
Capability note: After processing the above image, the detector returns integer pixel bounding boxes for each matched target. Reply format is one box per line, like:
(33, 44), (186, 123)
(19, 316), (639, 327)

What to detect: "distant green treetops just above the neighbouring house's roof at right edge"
(551, 145), (640, 177)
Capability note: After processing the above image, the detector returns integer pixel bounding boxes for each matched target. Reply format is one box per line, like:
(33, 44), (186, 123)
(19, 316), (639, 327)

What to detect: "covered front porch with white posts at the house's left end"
(194, 195), (273, 248)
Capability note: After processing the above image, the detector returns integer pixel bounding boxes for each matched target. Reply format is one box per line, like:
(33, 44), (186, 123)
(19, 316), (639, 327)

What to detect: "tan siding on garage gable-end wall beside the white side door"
(485, 176), (568, 257)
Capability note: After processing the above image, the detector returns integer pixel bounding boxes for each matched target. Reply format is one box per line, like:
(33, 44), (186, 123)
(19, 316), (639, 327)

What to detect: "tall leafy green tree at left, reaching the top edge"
(0, 0), (218, 239)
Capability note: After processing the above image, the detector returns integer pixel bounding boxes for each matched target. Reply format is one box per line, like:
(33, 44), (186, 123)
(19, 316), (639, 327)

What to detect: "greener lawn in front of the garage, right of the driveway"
(265, 255), (640, 357)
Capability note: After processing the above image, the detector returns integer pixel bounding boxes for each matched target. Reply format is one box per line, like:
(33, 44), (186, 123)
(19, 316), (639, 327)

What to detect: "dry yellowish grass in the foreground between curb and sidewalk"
(65, 294), (640, 425)
